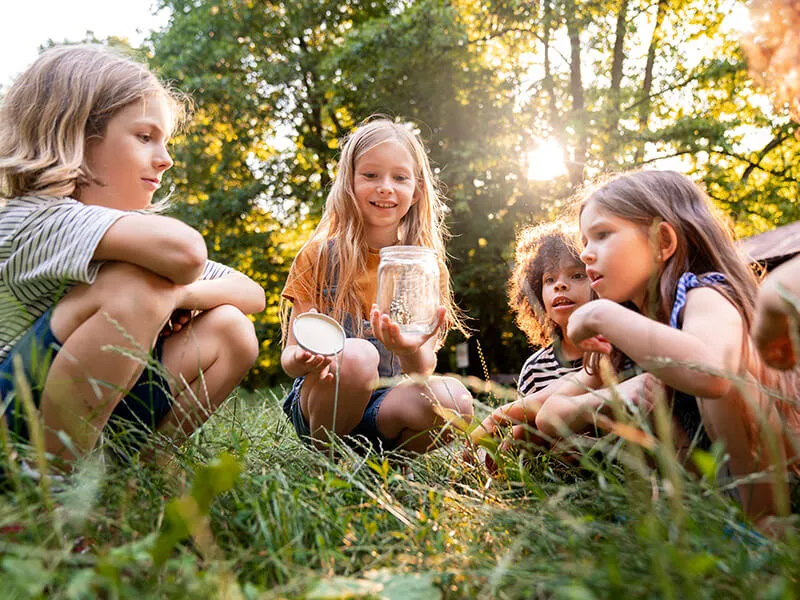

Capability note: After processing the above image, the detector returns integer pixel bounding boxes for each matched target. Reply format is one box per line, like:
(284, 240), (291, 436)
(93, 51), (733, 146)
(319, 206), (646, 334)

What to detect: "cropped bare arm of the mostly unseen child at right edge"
(753, 258), (800, 369)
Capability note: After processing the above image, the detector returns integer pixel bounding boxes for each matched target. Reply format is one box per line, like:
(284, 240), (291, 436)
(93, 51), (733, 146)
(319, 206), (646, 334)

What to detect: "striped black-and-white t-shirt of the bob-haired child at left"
(0, 196), (232, 362)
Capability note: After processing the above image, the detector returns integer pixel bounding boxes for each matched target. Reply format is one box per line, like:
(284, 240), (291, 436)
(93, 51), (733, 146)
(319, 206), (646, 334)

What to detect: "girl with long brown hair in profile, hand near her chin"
(536, 171), (794, 518)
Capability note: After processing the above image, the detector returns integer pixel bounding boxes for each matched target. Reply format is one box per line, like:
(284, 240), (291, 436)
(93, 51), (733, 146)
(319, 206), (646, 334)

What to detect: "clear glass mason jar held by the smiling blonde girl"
(377, 246), (440, 335)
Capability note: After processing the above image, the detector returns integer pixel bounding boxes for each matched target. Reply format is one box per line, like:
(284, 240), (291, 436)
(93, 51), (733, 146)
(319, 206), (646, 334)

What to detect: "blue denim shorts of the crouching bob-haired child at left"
(0, 310), (173, 451)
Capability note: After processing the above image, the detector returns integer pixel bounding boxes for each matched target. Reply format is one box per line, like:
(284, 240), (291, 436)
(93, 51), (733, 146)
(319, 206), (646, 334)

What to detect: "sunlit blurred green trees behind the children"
(128, 0), (800, 385)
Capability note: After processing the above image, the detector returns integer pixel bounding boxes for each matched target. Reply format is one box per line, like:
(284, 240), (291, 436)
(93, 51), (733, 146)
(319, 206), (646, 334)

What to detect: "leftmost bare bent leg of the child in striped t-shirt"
(40, 263), (177, 460)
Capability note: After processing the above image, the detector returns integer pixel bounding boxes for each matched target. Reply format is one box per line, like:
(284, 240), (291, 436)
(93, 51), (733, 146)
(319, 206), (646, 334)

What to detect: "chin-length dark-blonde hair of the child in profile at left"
(0, 45), (188, 198)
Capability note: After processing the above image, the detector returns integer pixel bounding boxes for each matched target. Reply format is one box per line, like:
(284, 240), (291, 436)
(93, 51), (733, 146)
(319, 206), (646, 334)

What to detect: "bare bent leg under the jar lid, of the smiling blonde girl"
(300, 338), (380, 440)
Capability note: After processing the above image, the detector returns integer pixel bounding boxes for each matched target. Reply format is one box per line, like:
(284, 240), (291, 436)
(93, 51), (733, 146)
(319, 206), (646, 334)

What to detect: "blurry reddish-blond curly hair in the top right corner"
(742, 0), (800, 122)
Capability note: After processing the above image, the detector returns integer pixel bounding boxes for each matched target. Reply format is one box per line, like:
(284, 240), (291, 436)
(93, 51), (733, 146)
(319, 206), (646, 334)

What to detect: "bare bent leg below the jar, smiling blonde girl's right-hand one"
(378, 377), (473, 452)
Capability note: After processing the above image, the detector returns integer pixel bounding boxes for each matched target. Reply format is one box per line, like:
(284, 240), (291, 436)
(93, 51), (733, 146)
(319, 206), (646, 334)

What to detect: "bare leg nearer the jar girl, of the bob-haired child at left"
(159, 304), (258, 443)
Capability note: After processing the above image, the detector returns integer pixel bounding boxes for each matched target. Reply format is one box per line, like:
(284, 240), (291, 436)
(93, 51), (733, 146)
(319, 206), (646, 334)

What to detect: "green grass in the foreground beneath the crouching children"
(0, 390), (800, 599)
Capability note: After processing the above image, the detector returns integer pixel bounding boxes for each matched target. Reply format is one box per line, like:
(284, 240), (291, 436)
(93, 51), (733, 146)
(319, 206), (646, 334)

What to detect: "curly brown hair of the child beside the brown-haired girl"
(508, 222), (583, 346)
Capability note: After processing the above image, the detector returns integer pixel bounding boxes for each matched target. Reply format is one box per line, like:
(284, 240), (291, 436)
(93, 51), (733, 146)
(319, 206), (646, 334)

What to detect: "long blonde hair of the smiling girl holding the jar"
(283, 117), (466, 341)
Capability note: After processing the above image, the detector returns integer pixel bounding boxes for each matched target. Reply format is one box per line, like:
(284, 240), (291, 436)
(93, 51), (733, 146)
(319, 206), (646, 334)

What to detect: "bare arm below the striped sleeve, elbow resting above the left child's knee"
(94, 213), (208, 284)
